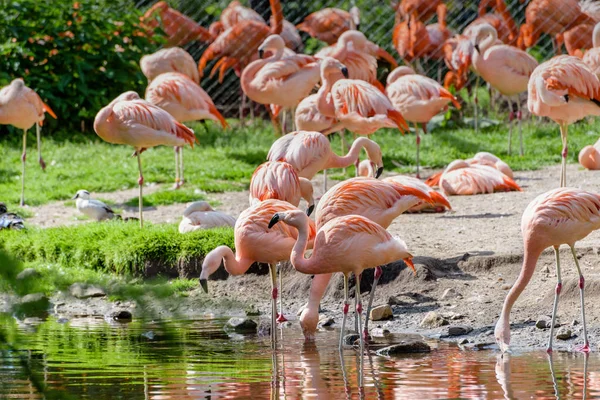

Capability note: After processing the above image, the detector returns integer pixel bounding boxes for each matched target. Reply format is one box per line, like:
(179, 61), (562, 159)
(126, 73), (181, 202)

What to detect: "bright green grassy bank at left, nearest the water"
(0, 221), (233, 275)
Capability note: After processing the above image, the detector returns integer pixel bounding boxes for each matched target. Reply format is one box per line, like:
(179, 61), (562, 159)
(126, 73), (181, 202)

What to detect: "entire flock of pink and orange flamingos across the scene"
(5, 0), (600, 384)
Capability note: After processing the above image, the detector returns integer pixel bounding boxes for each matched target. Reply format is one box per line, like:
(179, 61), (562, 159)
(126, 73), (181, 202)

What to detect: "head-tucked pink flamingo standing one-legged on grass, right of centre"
(385, 67), (460, 178)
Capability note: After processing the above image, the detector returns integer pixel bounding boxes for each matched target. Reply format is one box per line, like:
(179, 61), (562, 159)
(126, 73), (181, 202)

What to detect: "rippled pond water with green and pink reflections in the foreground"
(0, 319), (600, 400)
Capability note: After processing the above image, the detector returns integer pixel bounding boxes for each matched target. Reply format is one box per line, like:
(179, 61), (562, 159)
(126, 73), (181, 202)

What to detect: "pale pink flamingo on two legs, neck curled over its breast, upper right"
(472, 23), (538, 156)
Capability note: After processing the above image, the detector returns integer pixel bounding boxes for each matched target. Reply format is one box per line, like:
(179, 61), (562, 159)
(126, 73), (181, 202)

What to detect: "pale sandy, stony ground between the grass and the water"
(14, 165), (600, 349)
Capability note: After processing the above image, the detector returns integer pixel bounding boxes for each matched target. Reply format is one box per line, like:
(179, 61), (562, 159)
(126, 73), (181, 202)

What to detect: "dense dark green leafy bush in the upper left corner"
(0, 0), (162, 133)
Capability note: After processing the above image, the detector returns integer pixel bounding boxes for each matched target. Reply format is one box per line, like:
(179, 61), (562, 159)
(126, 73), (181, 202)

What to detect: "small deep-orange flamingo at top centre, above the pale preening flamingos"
(296, 7), (360, 44)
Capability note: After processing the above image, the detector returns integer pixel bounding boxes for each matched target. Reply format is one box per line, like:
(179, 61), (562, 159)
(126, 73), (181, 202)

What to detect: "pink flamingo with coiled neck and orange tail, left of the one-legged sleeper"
(317, 57), (408, 135)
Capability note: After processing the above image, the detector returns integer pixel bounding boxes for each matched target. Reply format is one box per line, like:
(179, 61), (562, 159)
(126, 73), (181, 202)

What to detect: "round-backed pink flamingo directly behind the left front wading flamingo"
(249, 161), (315, 215)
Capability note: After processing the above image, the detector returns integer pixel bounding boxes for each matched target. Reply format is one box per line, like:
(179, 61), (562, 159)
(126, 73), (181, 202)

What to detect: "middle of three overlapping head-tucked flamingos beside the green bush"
(146, 72), (228, 189)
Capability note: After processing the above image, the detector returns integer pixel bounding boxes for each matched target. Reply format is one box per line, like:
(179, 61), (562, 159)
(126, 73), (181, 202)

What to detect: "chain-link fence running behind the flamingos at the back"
(137, 0), (597, 116)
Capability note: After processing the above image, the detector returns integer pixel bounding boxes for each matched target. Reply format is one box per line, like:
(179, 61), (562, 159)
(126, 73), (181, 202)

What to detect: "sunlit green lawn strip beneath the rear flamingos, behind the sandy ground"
(0, 112), (599, 207)
